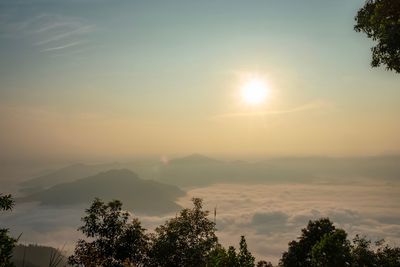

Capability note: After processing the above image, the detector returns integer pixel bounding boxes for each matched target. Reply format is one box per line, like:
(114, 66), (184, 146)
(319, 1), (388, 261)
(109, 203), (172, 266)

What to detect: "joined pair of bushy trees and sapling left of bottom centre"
(69, 198), (266, 267)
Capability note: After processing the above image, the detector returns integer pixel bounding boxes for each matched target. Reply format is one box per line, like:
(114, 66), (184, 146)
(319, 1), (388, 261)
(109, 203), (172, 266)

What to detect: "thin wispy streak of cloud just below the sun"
(214, 101), (334, 119)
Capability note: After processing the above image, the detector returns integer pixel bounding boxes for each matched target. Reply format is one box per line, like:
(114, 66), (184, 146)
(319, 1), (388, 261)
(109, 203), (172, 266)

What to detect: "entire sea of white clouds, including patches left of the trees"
(0, 183), (400, 263)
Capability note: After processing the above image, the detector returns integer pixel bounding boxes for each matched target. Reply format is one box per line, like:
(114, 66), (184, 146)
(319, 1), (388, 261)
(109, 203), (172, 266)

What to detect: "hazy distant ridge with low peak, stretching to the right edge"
(155, 154), (400, 187)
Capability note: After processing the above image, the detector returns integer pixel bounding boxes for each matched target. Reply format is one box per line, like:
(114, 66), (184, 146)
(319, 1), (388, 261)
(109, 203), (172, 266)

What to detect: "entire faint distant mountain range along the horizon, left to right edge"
(21, 154), (400, 193)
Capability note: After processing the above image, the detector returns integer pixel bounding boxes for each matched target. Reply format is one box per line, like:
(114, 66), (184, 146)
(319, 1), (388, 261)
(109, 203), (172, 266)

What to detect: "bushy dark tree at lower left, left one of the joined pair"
(68, 198), (149, 267)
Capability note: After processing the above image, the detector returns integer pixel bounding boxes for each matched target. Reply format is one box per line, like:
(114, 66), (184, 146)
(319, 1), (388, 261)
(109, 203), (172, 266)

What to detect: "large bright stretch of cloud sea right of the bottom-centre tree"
(180, 184), (400, 262)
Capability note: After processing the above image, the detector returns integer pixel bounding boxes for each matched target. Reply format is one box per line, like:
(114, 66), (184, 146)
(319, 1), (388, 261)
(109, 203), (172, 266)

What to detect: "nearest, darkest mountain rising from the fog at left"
(19, 169), (185, 215)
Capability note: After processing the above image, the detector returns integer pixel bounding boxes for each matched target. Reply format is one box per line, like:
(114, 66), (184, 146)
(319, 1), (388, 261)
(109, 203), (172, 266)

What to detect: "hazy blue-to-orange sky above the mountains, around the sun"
(0, 0), (400, 159)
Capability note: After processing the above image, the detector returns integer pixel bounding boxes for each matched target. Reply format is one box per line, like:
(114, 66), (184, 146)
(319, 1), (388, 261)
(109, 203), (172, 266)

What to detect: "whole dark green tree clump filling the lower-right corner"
(279, 218), (400, 267)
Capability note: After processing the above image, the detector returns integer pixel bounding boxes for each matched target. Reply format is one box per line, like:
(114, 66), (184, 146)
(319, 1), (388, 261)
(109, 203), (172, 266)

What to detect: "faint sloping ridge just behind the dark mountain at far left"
(20, 163), (119, 193)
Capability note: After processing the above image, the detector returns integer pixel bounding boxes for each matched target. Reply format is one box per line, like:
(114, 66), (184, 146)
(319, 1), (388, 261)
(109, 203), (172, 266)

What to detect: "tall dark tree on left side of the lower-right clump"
(279, 218), (336, 267)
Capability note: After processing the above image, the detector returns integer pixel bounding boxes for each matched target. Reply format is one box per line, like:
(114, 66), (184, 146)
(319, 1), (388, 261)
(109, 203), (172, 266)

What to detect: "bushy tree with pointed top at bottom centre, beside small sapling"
(151, 198), (218, 266)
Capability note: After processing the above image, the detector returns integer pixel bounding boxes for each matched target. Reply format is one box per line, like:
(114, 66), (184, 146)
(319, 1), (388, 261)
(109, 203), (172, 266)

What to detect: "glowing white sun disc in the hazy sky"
(241, 78), (269, 106)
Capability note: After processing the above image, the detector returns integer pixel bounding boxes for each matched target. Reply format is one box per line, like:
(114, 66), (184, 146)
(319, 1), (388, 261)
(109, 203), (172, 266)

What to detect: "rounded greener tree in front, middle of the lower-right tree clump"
(311, 229), (352, 267)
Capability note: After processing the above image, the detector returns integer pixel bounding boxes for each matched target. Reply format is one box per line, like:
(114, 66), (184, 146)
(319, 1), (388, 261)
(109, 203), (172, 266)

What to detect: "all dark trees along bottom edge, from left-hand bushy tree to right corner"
(64, 198), (400, 267)
